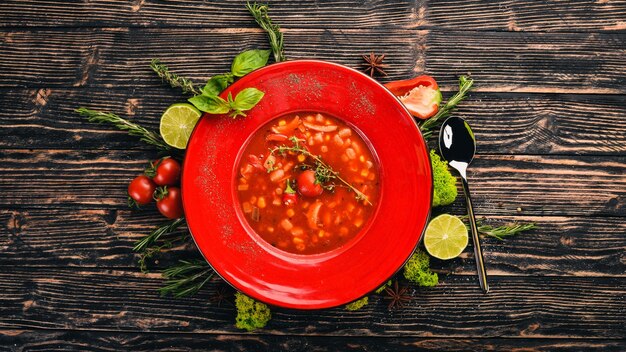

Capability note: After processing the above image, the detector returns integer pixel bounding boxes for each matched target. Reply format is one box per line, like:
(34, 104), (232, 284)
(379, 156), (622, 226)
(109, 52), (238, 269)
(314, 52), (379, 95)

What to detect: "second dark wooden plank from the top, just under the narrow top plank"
(0, 28), (626, 94)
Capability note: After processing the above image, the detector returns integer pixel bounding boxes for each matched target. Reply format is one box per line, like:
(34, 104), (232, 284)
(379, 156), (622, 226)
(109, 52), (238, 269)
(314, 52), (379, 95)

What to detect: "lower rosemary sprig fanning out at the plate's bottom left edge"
(159, 260), (215, 298)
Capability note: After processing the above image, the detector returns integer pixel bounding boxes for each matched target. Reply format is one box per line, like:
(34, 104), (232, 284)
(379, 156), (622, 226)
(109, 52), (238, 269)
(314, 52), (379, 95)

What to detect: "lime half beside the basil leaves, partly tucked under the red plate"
(160, 103), (202, 149)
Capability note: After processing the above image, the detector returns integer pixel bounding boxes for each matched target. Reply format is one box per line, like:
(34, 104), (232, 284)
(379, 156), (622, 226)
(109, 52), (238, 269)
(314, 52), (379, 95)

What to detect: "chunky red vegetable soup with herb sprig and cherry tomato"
(236, 113), (379, 254)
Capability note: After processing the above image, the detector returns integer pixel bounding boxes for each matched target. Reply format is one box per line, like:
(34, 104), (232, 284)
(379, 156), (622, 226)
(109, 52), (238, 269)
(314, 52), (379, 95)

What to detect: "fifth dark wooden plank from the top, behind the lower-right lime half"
(0, 209), (626, 277)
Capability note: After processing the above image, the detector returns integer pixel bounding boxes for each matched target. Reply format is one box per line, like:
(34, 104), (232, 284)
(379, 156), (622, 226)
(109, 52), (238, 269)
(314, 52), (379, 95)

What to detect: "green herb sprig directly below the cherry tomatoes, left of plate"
(133, 218), (189, 273)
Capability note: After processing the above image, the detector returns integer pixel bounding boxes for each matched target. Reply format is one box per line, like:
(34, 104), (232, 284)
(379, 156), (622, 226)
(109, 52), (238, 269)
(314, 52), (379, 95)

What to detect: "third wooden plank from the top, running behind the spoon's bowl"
(0, 87), (626, 155)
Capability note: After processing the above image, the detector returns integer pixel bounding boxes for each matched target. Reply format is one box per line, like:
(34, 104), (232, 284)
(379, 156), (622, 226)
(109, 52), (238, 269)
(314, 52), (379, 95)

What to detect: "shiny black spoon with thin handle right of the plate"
(439, 117), (489, 293)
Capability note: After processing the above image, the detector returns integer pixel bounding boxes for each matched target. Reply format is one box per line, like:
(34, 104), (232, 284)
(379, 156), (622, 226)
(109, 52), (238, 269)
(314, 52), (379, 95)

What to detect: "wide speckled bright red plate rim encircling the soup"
(182, 60), (432, 309)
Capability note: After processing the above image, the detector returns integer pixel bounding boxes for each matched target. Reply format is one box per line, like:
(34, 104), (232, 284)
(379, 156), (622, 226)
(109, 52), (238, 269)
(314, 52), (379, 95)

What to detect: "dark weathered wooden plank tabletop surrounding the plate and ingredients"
(0, 0), (626, 351)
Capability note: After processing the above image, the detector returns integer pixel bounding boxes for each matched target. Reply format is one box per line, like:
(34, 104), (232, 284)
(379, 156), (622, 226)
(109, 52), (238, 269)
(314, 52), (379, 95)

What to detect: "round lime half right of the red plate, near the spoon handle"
(424, 214), (468, 260)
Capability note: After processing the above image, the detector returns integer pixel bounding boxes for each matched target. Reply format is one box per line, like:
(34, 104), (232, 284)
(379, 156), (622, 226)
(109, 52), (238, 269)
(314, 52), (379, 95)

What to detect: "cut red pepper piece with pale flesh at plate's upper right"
(385, 76), (441, 120)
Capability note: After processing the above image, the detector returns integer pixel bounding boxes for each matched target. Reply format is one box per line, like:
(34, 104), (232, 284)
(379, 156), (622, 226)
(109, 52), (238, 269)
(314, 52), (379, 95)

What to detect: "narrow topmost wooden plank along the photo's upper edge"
(0, 0), (626, 32)
